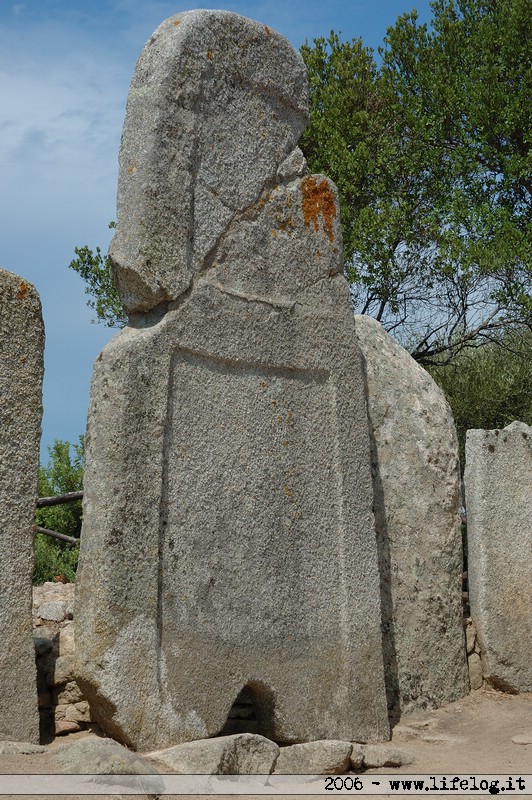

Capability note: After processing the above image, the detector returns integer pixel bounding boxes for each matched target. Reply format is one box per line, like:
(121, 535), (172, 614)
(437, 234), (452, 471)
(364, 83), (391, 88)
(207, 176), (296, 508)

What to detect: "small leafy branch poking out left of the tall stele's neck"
(69, 222), (127, 328)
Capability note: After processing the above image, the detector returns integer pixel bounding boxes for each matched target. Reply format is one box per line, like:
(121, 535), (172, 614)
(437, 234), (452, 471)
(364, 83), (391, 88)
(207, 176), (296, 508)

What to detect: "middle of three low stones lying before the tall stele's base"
(274, 740), (353, 775)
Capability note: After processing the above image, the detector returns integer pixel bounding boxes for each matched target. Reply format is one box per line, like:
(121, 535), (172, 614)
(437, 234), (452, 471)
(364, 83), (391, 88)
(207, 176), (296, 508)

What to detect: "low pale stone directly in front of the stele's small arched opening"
(147, 733), (279, 775)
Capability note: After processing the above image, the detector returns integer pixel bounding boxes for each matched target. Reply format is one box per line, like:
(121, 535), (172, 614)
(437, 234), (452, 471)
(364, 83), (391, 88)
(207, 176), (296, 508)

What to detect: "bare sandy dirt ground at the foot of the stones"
(0, 689), (532, 800)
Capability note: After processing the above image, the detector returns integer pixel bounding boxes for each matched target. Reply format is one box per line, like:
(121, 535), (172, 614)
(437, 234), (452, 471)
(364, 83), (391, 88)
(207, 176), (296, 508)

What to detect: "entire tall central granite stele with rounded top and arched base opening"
(75, 11), (389, 749)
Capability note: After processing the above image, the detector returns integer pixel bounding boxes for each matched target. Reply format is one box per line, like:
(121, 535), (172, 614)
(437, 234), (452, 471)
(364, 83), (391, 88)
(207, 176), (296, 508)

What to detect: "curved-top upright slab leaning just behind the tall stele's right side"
(355, 316), (469, 718)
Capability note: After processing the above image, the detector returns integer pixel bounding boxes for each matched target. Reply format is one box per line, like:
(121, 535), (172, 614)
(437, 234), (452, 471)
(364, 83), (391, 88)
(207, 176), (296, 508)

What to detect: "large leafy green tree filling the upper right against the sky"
(301, 0), (532, 365)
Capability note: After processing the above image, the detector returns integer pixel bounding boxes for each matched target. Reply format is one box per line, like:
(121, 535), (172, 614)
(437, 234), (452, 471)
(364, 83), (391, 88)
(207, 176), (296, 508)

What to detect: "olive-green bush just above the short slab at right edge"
(429, 331), (532, 465)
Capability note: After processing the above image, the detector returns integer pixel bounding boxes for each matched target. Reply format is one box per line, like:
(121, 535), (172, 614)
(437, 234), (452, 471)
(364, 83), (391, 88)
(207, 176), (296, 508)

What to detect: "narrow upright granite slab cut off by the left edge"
(0, 269), (44, 742)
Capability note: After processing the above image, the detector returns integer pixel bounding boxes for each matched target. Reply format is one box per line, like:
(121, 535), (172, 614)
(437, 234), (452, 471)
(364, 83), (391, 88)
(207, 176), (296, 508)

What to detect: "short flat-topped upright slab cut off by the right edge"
(465, 422), (532, 692)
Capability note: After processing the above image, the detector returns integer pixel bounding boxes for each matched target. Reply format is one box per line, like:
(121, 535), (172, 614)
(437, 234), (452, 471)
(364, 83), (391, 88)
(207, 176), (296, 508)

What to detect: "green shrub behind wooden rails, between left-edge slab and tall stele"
(33, 436), (84, 584)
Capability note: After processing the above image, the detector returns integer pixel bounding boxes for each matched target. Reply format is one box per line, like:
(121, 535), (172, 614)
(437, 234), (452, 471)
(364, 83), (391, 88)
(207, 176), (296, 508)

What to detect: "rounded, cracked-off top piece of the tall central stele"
(110, 11), (307, 312)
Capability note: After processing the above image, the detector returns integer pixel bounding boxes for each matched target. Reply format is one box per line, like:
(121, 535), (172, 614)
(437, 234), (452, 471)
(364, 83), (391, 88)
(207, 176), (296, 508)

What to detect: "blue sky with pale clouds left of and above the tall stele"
(0, 0), (430, 460)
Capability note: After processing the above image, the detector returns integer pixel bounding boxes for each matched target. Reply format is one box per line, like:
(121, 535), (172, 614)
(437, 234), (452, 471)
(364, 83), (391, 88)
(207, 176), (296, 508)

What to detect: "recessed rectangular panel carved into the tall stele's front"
(160, 352), (348, 654)
